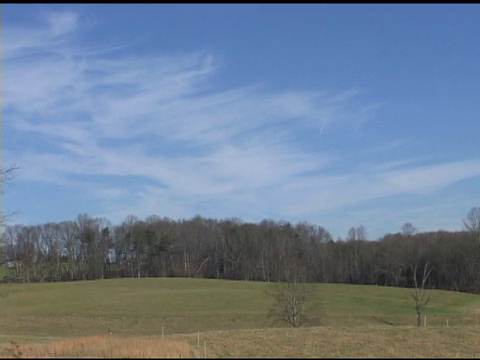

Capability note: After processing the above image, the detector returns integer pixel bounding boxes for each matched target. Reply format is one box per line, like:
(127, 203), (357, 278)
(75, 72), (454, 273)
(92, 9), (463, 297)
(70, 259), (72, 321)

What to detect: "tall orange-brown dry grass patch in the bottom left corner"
(3, 335), (196, 358)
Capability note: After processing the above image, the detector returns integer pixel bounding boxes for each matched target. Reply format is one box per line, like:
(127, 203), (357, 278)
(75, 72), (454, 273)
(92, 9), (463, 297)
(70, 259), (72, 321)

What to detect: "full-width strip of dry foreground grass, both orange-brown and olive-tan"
(2, 325), (480, 358)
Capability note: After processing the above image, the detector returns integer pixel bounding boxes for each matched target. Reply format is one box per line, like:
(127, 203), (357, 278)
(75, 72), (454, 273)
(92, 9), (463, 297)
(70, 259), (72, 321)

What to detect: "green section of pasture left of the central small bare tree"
(0, 278), (274, 336)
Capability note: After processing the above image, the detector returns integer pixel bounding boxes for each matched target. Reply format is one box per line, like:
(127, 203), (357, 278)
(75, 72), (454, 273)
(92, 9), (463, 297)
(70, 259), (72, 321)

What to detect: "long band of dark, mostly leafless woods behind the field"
(0, 208), (480, 292)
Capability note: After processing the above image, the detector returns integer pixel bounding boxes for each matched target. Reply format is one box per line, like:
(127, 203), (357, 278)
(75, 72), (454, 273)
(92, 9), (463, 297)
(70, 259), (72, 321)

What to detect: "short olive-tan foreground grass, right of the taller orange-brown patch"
(176, 325), (480, 358)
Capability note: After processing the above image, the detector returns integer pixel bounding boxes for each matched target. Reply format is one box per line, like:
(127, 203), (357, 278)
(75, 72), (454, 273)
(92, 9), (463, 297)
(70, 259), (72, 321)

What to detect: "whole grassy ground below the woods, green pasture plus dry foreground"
(0, 278), (480, 357)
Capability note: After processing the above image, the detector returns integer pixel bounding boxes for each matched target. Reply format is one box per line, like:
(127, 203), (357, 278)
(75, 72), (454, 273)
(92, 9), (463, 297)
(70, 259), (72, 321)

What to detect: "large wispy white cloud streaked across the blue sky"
(4, 13), (480, 232)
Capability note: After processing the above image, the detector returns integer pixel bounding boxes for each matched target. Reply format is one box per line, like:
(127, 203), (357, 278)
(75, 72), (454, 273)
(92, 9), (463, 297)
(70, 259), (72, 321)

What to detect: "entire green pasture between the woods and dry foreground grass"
(0, 278), (480, 342)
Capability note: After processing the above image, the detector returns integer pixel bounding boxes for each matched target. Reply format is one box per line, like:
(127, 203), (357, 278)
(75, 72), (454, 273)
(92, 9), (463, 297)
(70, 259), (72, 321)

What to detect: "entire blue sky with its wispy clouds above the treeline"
(2, 4), (480, 239)
